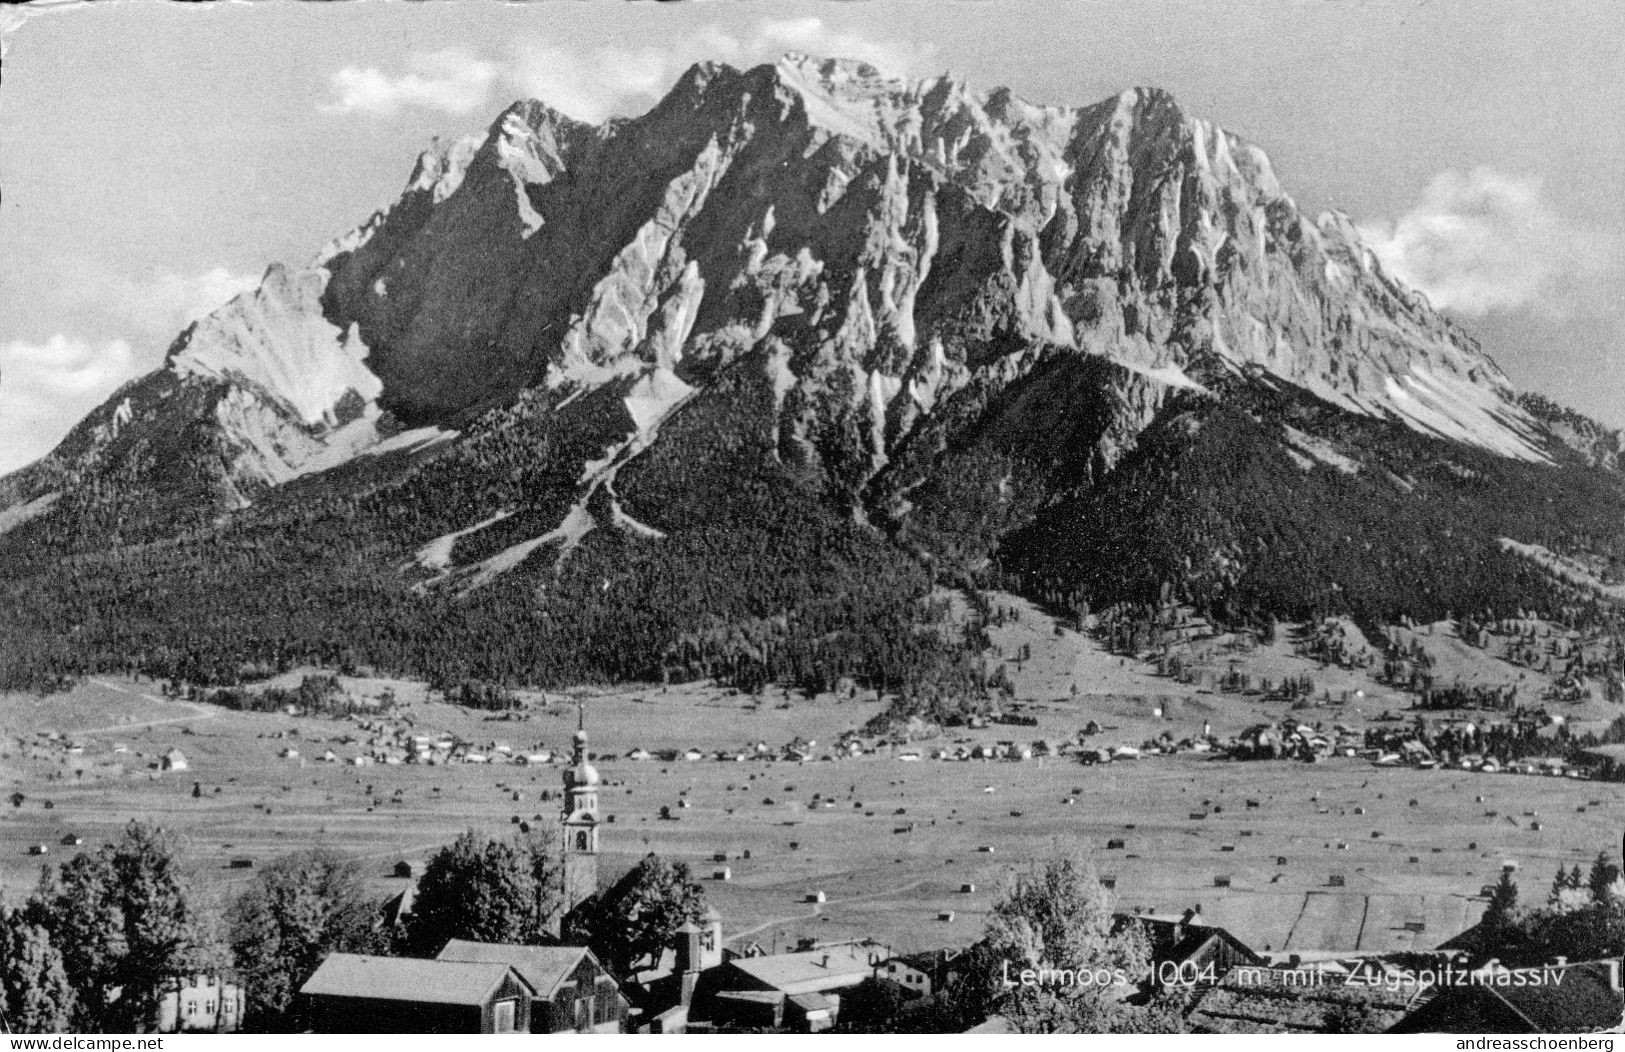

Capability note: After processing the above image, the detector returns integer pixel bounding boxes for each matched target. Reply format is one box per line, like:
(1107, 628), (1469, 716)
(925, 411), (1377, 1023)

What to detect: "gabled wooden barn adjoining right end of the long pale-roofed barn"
(436, 938), (629, 1034)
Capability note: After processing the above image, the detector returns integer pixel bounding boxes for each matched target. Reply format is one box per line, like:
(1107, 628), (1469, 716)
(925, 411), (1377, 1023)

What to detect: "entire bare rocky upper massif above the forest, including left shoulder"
(8, 55), (1566, 559)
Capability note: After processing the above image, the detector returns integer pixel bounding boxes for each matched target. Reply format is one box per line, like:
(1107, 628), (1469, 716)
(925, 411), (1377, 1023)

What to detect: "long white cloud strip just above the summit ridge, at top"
(505, 18), (933, 122)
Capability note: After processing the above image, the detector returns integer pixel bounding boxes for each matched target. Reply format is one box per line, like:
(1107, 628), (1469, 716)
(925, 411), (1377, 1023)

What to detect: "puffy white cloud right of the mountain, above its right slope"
(1362, 167), (1610, 315)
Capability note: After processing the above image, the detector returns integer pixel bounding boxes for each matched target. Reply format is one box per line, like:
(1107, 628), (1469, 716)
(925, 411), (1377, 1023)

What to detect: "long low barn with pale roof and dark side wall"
(299, 953), (535, 1034)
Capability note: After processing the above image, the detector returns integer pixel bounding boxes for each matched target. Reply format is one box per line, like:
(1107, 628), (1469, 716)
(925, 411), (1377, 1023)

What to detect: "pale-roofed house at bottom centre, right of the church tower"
(705, 941), (895, 1032)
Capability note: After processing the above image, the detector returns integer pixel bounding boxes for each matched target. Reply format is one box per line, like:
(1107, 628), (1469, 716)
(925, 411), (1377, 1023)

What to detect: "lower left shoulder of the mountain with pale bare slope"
(7, 265), (390, 540)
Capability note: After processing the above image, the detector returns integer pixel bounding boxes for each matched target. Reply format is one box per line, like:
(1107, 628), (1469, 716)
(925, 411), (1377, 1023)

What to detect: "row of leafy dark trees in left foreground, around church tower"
(0, 823), (705, 1032)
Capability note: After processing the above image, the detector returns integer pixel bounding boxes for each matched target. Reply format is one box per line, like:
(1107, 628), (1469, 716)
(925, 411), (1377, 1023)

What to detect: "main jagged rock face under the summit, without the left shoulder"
(310, 57), (1542, 478)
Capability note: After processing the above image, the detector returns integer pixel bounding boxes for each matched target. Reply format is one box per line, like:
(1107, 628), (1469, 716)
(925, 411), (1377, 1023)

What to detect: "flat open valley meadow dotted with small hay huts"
(0, 647), (1625, 951)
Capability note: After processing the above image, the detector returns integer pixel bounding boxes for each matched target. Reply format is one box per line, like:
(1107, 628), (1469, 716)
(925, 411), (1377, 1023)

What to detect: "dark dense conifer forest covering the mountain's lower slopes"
(0, 347), (1625, 711)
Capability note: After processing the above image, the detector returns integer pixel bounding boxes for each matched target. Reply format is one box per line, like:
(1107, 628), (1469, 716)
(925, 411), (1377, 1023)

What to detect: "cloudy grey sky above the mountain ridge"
(0, 0), (1625, 473)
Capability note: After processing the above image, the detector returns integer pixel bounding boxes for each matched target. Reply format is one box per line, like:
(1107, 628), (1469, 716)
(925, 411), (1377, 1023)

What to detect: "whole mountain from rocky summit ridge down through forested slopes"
(0, 55), (1622, 689)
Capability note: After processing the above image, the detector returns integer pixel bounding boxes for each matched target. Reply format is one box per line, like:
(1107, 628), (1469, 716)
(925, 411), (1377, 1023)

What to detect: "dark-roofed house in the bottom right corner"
(1388, 959), (1625, 1034)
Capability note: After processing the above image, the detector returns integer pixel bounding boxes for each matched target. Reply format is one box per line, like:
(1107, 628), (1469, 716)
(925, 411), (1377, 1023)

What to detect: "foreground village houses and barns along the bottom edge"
(282, 909), (1625, 1034)
